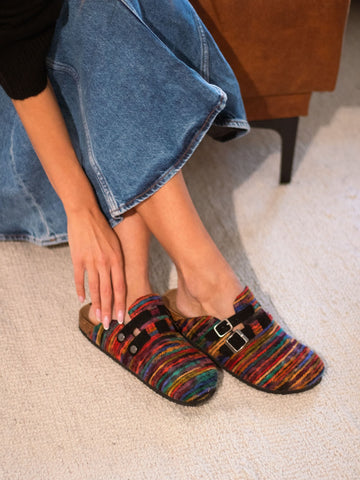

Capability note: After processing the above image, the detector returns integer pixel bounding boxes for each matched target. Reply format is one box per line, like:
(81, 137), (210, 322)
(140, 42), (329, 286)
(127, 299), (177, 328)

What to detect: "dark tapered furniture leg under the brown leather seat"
(249, 117), (299, 183)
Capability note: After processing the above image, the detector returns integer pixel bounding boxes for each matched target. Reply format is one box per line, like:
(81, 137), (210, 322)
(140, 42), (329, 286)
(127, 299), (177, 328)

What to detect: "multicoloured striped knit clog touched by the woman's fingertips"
(79, 295), (217, 405)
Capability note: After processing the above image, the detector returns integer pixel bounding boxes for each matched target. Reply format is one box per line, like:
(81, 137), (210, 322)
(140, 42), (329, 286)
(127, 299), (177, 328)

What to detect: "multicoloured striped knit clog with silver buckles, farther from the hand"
(163, 287), (324, 394)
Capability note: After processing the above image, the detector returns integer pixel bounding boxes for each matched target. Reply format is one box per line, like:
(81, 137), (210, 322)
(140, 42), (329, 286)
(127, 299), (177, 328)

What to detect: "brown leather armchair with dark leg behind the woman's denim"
(191, 0), (350, 183)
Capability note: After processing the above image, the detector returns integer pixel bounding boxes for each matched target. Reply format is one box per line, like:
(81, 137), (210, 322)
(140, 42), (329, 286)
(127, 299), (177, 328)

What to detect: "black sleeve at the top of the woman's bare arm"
(0, 0), (63, 100)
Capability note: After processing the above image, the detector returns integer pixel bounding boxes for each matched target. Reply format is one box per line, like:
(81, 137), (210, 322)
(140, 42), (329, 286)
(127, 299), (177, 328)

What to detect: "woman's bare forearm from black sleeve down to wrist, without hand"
(13, 82), (98, 214)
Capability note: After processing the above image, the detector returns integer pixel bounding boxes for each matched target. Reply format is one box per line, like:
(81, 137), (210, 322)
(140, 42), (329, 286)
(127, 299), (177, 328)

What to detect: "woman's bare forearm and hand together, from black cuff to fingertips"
(13, 83), (125, 328)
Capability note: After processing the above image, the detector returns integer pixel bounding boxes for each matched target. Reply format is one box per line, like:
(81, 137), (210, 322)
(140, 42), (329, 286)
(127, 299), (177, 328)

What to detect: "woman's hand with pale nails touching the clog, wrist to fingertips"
(67, 208), (126, 329)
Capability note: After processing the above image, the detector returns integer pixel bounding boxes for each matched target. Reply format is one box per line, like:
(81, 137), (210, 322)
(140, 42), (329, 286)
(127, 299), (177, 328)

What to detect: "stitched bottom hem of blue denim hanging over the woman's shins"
(109, 85), (227, 221)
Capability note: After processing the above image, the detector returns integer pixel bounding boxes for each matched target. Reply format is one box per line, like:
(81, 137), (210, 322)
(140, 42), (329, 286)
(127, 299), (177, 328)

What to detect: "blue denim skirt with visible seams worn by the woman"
(0, 0), (249, 245)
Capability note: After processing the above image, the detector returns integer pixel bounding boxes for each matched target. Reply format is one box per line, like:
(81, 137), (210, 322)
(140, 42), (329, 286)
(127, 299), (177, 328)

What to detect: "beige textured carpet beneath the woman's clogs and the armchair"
(0, 2), (360, 480)
